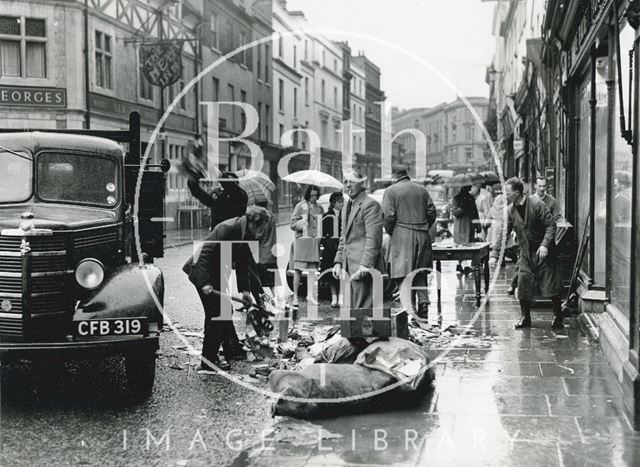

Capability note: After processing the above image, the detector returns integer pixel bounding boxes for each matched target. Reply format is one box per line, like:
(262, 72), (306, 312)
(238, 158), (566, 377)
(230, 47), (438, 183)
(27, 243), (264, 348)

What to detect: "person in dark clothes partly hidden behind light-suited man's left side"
(320, 191), (344, 308)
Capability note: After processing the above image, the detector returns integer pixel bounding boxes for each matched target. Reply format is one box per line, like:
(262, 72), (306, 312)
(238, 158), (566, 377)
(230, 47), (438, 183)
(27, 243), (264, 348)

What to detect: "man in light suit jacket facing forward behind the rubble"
(333, 172), (384, 308)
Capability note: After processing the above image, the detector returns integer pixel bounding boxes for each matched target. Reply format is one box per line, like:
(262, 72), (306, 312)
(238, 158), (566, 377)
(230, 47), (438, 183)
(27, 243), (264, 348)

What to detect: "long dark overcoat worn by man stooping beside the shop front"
(507, 196), (562, 300)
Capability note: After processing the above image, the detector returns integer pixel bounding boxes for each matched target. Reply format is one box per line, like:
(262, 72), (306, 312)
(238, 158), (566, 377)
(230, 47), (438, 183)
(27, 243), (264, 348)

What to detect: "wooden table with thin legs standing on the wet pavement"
(432, 242), (491, 306)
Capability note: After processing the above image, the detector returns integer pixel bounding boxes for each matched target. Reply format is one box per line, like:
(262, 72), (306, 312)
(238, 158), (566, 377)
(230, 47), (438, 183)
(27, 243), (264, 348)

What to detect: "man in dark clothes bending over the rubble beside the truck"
(182, 206), (270, 370)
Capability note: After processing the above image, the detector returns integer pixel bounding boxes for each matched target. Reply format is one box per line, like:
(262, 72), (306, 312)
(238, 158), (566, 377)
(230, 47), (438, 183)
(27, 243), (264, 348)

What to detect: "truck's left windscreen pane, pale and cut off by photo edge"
(0, 151), (33, 203)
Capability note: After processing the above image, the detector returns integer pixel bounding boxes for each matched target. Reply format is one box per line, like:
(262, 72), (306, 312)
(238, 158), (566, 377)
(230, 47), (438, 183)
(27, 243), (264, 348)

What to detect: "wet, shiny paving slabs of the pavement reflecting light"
(234, 263), (640, 466)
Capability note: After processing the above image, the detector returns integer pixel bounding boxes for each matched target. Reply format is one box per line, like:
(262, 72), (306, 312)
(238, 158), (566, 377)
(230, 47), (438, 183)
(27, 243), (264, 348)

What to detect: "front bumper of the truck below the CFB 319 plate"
(0, 336), (160, 360)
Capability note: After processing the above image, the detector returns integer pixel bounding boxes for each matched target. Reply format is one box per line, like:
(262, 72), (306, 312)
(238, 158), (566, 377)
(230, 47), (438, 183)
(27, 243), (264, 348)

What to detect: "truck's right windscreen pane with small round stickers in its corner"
(37, 152), (119, 206)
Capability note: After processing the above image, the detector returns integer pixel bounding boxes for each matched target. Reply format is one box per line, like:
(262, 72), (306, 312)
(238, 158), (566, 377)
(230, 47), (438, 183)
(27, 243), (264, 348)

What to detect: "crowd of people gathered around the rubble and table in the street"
(183, 163), (562, 369)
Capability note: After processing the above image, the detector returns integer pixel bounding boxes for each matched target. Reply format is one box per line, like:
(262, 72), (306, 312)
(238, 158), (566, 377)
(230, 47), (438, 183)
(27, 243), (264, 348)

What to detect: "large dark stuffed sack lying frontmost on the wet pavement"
(269, 363), (396, 419)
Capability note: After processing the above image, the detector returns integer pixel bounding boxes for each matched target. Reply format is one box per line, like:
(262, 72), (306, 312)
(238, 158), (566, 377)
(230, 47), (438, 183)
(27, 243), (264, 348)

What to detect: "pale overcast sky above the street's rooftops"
(287, 0), (496, 109)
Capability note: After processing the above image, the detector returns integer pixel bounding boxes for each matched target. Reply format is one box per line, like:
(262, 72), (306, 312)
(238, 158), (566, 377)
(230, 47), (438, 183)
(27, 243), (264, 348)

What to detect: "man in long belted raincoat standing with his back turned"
(382, 169), (436, 319)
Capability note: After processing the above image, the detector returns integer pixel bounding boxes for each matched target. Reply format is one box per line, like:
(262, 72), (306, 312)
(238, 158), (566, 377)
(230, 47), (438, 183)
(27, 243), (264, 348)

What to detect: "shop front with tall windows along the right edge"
(545, 0), (640, 429)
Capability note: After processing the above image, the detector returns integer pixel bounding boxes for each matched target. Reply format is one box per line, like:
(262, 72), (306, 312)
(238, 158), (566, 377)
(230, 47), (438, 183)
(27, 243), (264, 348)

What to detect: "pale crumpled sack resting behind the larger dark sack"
(355, 337), (435, 391)
